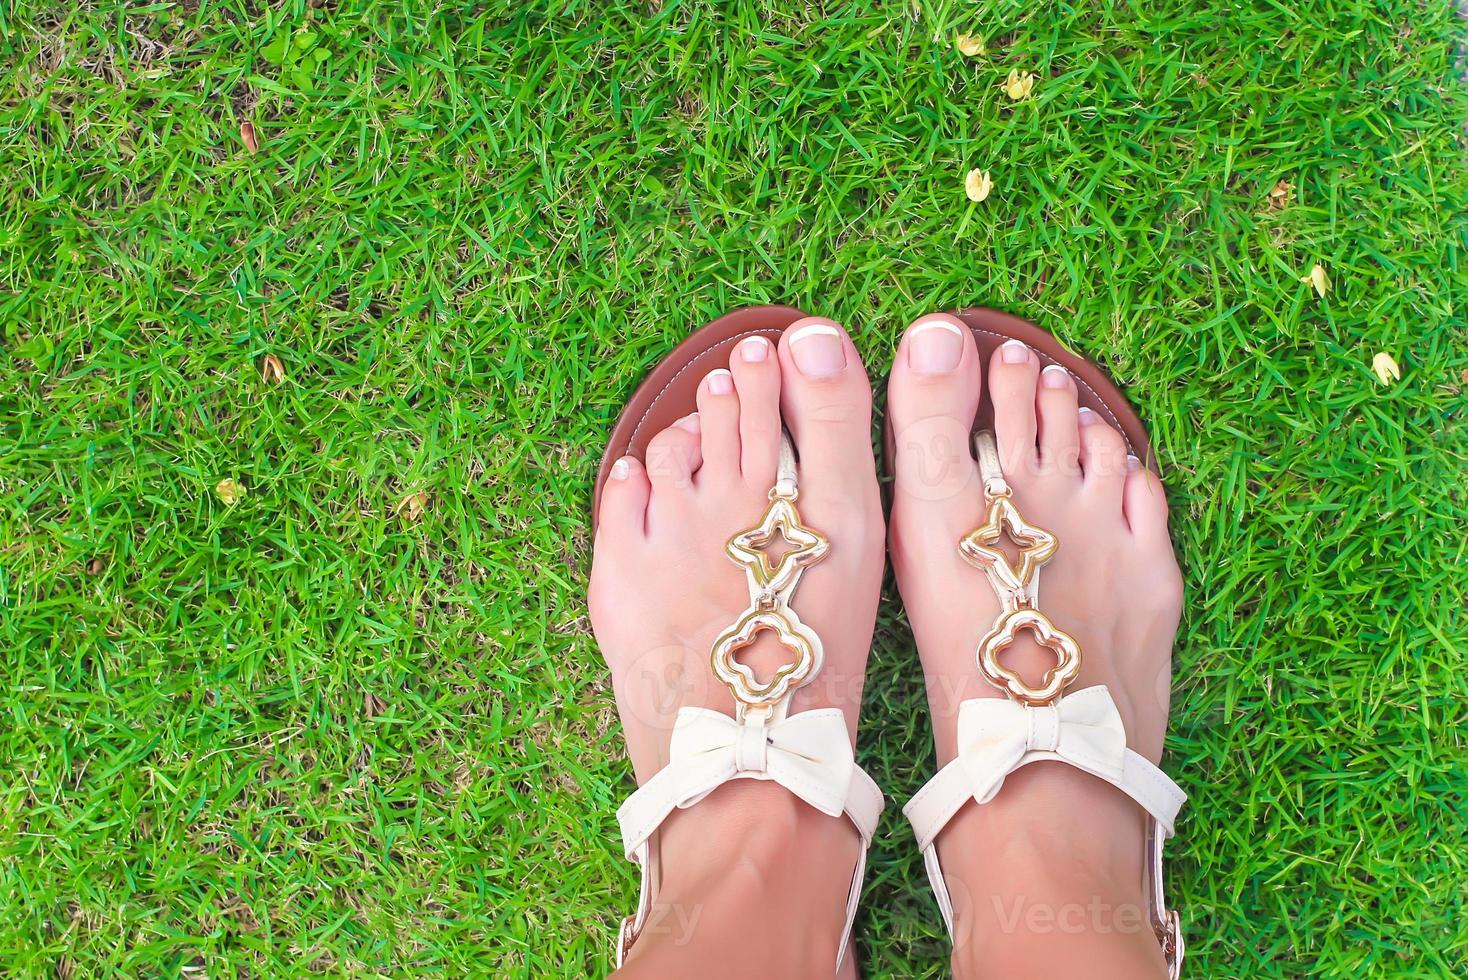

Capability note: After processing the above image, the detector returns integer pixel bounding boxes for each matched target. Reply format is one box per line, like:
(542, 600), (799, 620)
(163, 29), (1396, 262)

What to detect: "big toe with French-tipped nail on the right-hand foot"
(887, 314), (982, 515)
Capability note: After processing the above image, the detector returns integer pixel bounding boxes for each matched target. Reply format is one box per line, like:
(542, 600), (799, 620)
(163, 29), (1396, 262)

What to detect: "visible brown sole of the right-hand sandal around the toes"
(884, 307), (1161, 475)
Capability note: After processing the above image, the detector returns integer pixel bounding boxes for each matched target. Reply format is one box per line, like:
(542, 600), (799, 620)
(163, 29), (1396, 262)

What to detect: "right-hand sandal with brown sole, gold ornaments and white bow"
(885, 308), (1188, 980)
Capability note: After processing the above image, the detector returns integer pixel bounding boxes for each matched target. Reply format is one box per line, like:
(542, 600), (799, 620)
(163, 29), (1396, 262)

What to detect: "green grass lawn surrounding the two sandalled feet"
(0, 0), (1468, 977)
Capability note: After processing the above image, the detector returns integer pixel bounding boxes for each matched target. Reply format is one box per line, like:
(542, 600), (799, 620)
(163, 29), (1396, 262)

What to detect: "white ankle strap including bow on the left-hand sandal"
(617, 707), (882, 970)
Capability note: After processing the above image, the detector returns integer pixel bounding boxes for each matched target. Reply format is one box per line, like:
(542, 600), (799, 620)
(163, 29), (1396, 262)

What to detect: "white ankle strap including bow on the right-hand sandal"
(903, 687), (1188, 962)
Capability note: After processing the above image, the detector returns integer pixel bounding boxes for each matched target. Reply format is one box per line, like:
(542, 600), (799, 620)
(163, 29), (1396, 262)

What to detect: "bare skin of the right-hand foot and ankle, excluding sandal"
(888, 314), (1182, 977)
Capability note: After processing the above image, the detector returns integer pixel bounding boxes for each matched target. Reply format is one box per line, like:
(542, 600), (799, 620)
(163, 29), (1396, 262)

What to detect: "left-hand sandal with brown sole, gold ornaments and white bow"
(593, 307), (884, 971)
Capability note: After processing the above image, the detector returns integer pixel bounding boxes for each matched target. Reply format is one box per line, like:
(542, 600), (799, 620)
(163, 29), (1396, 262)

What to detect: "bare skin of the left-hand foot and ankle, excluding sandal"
(589, 318), (885, 977)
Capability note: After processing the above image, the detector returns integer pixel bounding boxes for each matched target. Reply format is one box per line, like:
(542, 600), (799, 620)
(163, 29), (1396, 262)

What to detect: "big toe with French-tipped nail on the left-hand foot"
(780, 317), (876, 487)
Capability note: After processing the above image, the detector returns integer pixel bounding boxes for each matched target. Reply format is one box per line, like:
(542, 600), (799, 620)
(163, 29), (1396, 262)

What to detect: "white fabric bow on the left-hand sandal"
(659, 707), (856, 817)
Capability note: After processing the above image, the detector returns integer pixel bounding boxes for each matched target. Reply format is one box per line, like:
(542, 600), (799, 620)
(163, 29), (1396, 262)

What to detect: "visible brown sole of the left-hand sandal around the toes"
(592, 307), (806, 533)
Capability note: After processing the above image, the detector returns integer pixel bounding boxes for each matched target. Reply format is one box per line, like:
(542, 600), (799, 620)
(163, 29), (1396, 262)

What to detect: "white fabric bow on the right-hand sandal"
(959, 687), (1126, 804)
